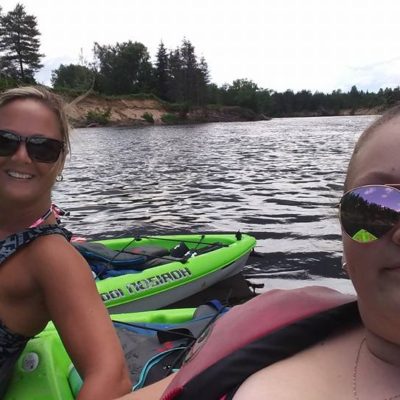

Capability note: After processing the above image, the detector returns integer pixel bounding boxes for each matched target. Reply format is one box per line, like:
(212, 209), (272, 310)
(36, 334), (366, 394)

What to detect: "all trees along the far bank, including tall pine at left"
(0, 4), (400, 117)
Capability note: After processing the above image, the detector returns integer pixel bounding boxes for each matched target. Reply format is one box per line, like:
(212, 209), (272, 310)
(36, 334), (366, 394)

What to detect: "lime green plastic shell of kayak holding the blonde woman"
(3, 306), (215, 400)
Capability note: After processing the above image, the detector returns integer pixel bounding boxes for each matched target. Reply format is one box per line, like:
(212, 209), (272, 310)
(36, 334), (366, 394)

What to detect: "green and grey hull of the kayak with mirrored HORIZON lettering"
(96, 234), (256, 314)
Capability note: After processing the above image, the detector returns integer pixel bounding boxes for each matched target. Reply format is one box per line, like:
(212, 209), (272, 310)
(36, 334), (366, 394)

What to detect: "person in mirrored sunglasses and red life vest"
(116, 107), (400, 400)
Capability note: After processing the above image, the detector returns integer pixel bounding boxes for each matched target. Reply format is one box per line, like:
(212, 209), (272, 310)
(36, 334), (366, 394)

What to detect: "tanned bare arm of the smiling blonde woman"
(35, 235), (131, 400)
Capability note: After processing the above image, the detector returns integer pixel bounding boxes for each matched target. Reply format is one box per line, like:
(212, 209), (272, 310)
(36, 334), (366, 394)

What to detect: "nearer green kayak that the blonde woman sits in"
(3, 306), (222, 400)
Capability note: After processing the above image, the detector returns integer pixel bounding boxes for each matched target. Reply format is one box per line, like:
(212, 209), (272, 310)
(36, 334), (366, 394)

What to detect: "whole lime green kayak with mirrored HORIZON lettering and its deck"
(82, 234), (256, 314)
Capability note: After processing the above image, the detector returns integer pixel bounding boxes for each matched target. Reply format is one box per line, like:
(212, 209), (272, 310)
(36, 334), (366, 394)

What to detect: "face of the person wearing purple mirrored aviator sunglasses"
(343, 117), (400, 334)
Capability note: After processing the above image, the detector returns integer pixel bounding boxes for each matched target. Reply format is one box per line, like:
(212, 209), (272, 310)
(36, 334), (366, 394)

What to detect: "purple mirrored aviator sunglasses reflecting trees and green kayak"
(339, 185), (400, 243)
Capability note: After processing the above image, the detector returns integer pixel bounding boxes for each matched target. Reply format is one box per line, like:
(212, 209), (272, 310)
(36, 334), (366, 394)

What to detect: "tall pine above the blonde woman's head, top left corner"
(0, 3), (43, 83)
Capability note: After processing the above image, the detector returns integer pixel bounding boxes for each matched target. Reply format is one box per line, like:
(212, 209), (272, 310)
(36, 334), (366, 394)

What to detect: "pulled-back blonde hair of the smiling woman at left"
(0, 86), (71, 152)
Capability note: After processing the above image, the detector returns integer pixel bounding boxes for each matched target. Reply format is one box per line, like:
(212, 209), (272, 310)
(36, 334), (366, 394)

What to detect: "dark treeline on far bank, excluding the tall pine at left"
(52, 39), (400, 117)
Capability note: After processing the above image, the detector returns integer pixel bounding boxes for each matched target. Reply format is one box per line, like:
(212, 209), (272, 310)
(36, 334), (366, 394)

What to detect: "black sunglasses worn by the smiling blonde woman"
(0, 130), (64, 163)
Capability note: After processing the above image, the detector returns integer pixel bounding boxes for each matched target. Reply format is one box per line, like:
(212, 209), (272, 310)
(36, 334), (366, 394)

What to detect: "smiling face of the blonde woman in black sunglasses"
(0, 99), (64, 205)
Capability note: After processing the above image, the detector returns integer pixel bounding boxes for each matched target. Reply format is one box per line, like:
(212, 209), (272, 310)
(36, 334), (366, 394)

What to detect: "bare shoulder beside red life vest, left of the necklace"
(233, 327), (363, 400)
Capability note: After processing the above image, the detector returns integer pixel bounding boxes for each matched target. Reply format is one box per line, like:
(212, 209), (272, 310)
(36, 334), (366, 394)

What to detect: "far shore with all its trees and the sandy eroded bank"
(0, 3), (394, 127)
